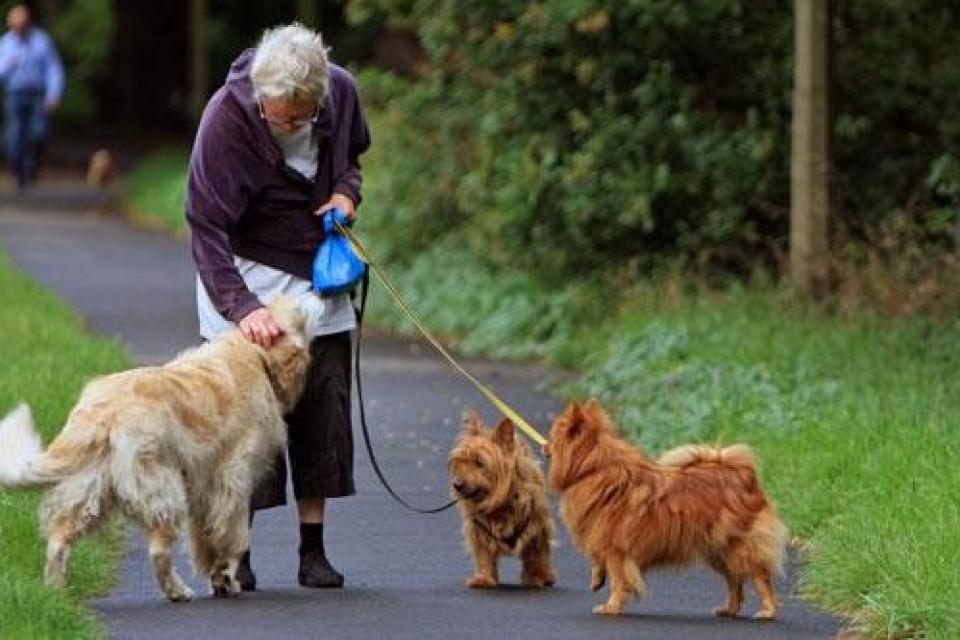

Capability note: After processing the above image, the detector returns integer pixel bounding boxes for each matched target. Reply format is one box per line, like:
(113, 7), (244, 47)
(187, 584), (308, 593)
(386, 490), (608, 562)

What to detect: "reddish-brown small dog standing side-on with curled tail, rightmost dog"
(545, 400), (786, 619)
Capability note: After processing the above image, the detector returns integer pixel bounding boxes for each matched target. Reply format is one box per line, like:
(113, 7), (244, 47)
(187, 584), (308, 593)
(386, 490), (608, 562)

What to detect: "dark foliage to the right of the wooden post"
(834, 0), (960, 232)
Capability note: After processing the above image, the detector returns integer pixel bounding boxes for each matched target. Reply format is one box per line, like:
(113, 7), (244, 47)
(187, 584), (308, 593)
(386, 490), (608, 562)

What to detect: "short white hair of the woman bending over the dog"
(250, 22), (330, 102)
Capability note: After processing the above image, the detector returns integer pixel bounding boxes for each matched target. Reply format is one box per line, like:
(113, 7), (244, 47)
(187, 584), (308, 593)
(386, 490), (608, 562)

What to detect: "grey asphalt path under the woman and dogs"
(0, 189), (841, 640)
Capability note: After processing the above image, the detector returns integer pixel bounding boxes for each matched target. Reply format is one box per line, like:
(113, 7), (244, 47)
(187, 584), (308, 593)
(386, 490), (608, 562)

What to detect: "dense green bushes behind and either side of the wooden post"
(348, 0), (960, 280)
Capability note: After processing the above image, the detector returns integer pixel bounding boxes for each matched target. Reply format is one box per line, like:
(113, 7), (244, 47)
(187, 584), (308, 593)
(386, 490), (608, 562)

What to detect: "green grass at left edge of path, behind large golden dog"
(0, 253), (128, 639)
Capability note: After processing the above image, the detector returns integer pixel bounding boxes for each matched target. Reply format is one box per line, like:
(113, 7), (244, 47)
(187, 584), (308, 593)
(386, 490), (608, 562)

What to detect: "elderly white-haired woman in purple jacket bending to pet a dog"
(186, 24), (370, 590)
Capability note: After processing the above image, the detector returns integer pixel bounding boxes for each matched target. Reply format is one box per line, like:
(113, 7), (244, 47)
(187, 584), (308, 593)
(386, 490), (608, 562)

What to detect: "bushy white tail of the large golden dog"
(0, 404), (95, 489)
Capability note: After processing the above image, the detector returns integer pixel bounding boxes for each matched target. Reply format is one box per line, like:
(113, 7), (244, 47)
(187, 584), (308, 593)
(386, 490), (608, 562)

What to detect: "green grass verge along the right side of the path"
(127, 139), (960, 640)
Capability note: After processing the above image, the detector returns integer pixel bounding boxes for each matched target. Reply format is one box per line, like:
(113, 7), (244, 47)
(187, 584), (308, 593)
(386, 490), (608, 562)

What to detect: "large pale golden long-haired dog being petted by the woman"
(0, 297), (310, 601)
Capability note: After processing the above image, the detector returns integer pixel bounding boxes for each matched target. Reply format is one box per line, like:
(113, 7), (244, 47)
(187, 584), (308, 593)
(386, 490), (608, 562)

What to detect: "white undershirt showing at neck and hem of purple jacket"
(197, 124), (357, 340)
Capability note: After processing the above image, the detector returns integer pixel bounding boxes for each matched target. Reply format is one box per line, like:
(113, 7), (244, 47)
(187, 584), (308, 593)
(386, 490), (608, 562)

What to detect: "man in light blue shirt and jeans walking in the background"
(0, 4), (63, 190)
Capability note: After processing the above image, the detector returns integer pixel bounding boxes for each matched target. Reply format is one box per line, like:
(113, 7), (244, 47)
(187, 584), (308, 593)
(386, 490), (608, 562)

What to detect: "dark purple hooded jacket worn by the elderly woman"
(186, 49), (370, 322)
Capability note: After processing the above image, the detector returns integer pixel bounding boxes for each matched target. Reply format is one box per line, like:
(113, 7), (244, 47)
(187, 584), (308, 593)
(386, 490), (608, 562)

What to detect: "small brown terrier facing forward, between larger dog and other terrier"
(447, 413), (556, 589)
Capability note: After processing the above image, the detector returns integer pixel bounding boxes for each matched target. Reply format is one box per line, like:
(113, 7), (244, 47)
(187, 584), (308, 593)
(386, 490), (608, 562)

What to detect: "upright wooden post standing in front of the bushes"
(790, 0), (832, 293)
